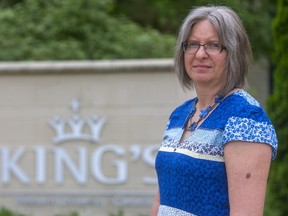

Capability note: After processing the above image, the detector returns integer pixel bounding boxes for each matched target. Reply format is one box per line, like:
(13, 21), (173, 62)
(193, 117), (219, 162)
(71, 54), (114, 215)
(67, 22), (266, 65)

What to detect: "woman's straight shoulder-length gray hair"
(174, 6), (252, 96)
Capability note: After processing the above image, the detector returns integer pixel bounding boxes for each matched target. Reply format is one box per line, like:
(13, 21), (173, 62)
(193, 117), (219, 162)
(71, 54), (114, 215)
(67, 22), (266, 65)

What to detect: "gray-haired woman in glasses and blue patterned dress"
(152, 6), (277, 216)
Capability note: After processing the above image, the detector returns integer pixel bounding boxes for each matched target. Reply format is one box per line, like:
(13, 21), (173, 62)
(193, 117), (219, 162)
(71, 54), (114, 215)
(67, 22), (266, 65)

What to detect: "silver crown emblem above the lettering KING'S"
(49, 99), (107, 144)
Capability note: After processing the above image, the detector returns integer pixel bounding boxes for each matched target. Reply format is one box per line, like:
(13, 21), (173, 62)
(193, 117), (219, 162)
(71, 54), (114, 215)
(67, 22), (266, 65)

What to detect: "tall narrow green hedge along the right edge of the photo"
(267, 0), (288, 216)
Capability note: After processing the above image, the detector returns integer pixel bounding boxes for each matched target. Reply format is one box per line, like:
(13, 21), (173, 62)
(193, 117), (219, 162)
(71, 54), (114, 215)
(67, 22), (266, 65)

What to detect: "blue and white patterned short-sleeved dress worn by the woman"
(155, 90), (277, 216)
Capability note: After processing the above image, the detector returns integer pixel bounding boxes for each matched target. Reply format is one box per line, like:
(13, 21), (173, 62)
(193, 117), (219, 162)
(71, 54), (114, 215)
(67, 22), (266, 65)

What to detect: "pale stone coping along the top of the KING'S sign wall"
(0, 59), (173, 75)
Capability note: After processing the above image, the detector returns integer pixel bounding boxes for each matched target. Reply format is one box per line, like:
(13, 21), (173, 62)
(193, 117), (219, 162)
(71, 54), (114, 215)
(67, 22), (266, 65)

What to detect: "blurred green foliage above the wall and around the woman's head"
(0, 0), (275, 61)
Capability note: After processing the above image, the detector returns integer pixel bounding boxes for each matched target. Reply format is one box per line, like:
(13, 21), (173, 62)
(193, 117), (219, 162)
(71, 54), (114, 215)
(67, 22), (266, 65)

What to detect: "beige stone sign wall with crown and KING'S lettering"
(0, 59), (267, 216)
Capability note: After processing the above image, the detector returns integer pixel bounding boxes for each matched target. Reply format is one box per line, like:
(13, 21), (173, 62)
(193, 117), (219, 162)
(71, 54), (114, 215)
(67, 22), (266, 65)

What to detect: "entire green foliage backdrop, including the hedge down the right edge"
(0, 0), (288, 216)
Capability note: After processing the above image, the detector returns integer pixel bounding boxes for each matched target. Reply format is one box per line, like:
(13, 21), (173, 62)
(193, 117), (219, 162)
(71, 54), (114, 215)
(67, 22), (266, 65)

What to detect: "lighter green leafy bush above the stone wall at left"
(0, 0), (175, 61)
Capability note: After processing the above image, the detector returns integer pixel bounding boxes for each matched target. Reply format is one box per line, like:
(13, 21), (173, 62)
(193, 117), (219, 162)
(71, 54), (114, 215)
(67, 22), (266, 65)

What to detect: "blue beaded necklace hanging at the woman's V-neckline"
(184, 96), (223, 132)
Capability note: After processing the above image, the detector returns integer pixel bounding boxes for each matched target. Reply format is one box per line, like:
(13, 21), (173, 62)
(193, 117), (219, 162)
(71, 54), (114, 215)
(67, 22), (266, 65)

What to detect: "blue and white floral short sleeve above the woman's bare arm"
(223, 116), (277, 159)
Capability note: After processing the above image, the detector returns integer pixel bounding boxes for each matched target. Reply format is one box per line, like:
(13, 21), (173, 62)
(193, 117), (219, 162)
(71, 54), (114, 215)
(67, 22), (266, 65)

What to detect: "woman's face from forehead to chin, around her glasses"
(184, 20), (227, 88)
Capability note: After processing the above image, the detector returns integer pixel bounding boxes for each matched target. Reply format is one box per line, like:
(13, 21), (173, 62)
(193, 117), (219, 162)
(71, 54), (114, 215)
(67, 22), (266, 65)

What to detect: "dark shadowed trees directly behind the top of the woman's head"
(114, 0), (275, 57)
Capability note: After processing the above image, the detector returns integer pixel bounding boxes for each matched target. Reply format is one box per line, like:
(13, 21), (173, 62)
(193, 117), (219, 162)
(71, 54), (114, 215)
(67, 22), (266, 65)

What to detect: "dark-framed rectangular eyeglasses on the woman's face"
(182, 41), (226, 55)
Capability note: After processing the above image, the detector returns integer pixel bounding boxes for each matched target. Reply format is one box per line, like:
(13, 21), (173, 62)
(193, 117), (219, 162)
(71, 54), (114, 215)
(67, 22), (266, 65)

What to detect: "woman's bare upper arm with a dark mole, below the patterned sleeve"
(224, 141), (272, 216)
